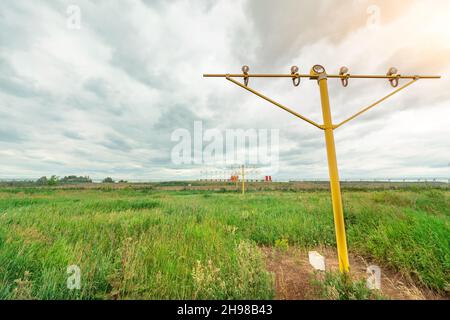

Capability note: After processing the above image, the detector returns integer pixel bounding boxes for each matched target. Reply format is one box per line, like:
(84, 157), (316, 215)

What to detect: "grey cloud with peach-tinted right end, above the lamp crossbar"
(239, 0), (410, 67)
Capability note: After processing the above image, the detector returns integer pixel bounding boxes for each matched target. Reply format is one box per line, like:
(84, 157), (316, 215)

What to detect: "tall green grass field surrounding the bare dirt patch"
(0, 186), (450, 299)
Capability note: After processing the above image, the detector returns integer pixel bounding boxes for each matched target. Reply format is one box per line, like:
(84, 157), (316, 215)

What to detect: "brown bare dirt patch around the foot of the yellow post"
(262, 247), (447, 300)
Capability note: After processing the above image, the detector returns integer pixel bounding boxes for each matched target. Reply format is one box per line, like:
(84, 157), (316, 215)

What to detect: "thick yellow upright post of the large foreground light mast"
(318, 72), (349, 273)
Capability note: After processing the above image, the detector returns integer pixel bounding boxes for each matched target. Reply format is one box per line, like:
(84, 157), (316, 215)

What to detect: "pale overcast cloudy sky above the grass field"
(0, 0), (450, 180)
